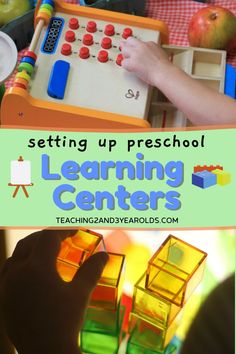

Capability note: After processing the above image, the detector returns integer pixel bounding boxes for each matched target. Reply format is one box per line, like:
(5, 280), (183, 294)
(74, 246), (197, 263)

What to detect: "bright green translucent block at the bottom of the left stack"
(80, 307), (125, 354)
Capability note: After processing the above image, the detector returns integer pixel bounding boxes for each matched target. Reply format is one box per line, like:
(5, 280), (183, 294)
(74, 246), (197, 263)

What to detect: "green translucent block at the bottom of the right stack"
(129, 312), (178, 352)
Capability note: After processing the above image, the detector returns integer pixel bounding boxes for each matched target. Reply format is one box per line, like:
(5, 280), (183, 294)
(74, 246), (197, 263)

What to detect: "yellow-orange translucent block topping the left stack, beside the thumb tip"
(89, 253), (125, 310)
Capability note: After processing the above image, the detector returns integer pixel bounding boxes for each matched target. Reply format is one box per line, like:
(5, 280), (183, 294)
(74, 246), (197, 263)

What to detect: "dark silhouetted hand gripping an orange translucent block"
(0, 230), (108, 354)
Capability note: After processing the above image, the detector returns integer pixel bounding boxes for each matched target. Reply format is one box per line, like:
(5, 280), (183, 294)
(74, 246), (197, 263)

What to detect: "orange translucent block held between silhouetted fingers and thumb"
(57, 229), (105, 281)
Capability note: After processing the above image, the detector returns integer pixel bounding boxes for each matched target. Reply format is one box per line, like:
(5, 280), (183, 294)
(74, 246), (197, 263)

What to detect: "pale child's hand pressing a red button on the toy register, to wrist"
(121, 37), (172, 86)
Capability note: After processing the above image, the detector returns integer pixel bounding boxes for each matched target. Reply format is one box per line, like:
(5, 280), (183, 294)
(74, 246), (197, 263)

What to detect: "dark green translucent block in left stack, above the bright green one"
(83, 306), (122, 334)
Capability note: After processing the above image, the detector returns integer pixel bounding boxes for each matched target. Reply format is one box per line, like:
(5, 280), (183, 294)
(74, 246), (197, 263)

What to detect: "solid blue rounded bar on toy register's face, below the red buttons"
(48, 60), (70, 100)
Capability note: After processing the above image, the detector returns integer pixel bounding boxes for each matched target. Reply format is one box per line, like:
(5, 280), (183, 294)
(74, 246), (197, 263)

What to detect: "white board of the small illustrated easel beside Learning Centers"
(11, 161), (31, 185)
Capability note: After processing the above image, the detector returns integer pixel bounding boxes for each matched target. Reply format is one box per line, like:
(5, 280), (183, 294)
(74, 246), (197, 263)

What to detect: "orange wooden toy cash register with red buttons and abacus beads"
(2, 0), (168, 129)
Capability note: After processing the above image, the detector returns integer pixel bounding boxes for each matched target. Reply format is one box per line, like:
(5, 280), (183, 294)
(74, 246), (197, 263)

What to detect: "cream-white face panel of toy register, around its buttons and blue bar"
(30, 13), (159, 119)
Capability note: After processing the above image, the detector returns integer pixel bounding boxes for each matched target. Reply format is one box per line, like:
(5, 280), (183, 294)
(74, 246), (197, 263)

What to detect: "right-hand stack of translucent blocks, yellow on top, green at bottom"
(127, 235), (207, 354)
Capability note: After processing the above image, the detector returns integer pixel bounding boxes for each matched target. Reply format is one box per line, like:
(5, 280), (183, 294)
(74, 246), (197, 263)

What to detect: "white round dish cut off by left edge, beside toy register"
(0, 31), (17, 84)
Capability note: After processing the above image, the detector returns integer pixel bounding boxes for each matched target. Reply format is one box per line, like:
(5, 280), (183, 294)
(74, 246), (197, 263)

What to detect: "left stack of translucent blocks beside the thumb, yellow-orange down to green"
(80, 253), (125, 354)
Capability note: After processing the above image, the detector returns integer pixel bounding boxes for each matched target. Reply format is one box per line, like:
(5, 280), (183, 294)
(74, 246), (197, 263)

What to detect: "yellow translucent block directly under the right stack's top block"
(132, 273), (181, 326)
